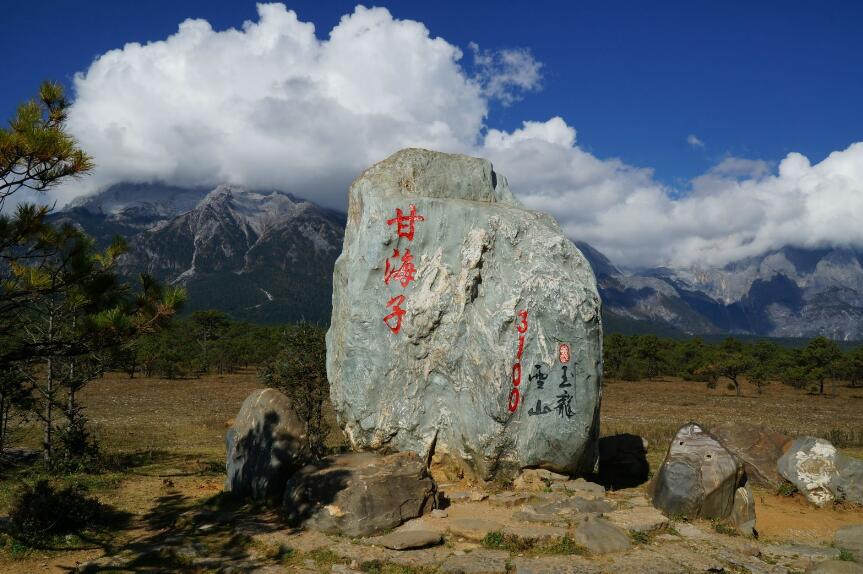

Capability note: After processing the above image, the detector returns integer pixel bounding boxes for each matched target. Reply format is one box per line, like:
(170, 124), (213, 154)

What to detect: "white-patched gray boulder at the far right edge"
(778, 437), (863, 506)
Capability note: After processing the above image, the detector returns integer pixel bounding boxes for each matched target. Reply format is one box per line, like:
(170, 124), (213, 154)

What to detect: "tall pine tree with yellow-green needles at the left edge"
(0, 83), (185, 464)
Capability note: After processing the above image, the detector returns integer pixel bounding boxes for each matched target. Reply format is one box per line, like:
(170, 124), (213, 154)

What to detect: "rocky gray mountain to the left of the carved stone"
(57, 185), (345, 322)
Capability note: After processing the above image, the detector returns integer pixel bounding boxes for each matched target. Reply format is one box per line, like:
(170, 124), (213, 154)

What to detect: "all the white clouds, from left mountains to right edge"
(66, 4), (863, 266)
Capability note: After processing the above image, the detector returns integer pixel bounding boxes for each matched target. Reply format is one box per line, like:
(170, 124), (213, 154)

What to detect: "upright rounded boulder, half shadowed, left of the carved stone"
(225, 389), (308, 501)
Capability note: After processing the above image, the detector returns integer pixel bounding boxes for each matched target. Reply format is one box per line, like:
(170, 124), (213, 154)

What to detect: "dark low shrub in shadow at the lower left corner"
(9, 480), (102, 546)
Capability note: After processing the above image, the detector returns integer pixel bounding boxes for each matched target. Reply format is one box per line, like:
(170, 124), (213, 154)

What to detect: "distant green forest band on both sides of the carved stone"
(121, 311), (863, 393)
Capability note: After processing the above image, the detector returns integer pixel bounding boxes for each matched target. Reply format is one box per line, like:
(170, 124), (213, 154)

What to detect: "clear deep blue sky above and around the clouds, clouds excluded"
(0, 0), (863, 183)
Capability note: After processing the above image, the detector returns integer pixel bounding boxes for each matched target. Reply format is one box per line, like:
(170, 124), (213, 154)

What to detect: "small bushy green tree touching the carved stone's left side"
(260, 323), (330, 454)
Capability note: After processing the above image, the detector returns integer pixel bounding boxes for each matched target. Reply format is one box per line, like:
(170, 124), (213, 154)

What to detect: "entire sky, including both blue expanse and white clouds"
(0, 0), (863, 265)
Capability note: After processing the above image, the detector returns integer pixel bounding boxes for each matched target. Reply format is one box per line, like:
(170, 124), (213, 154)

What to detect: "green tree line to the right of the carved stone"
(603, 334), (863, 394)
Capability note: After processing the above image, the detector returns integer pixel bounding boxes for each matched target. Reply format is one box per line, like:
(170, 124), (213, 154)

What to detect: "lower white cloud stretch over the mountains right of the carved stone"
(485, 118), (863, 266)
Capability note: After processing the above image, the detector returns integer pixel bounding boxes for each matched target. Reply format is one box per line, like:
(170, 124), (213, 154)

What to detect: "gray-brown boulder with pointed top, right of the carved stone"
(651, 423), (742, 518)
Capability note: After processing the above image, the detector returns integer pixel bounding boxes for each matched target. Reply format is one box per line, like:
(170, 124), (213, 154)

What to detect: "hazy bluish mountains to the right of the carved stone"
(579, 243), (863, 340)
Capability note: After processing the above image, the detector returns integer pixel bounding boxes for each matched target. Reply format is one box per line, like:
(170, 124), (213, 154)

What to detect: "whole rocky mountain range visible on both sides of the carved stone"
(53, 184), (863, 340)
